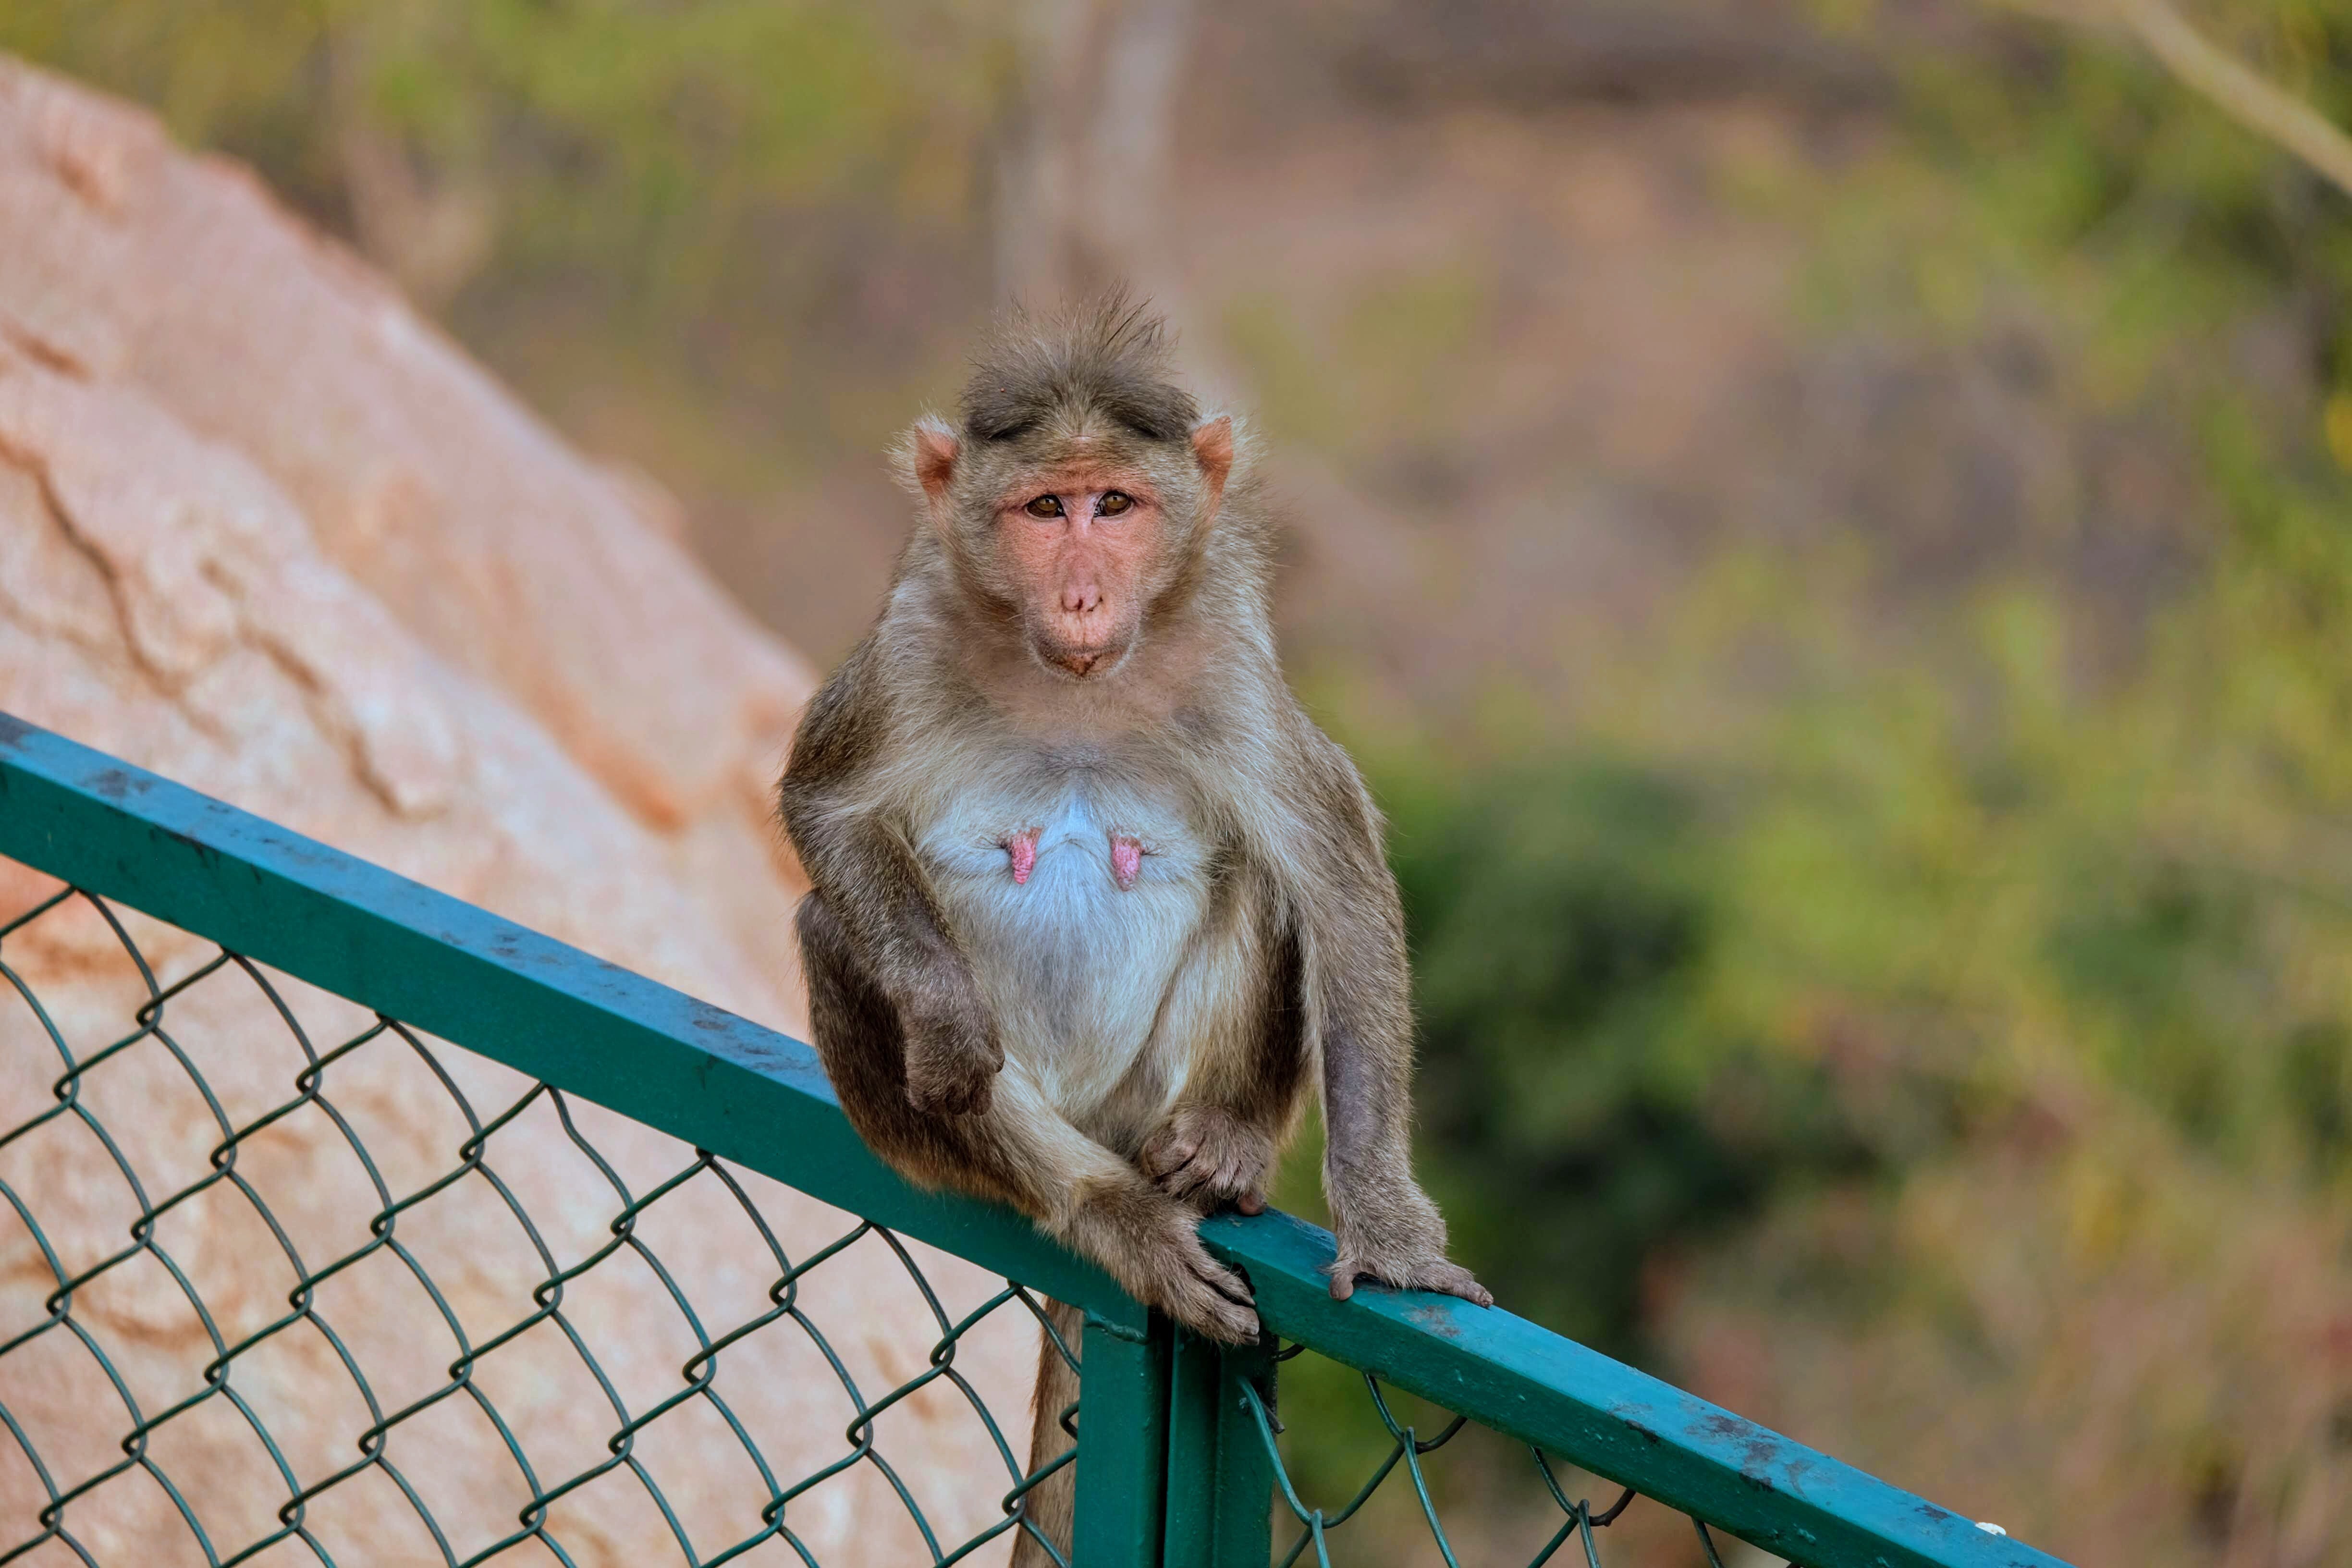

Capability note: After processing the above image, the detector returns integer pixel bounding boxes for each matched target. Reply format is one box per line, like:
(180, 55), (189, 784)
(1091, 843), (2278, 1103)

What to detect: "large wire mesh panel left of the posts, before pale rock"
(0, 889), (1077, 1568)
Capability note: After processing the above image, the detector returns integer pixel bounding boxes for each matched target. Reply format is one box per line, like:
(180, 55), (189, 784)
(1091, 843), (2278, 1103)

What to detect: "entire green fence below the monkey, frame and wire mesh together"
(0, 715), (2060, 1568)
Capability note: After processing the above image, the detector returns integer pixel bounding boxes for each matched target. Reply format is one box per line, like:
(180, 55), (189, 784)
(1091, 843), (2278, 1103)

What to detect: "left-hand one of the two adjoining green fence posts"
(1070, 1312), (1171, 1568)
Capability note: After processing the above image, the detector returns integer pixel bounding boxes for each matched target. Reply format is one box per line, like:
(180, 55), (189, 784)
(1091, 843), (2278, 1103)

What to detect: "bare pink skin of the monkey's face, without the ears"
(997, 463), (1162, 679)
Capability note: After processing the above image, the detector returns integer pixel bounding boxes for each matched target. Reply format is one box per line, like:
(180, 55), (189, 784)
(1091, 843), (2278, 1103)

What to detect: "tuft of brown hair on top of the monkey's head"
(960, 289), (1200, 442)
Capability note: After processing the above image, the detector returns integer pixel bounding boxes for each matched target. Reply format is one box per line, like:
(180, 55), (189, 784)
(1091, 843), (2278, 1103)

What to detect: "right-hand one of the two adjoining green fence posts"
(1164, 1328), (1275, 1568)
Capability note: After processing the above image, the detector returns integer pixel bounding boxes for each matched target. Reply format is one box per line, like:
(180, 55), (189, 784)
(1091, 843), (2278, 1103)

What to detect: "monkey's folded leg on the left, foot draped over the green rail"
(800, 894), (1258, 1345)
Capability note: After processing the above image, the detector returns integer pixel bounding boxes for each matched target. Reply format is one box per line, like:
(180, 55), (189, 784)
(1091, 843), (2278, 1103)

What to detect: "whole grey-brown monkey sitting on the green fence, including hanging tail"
(779, 294), (1494, 1563)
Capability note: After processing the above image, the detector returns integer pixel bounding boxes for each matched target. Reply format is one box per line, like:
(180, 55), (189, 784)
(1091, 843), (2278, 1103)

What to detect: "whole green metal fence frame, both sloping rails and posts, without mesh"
(0, 715), (2063, 1568)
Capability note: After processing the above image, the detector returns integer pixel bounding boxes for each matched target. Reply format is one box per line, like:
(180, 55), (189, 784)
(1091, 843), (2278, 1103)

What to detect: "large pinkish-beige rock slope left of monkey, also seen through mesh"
(0, 59), (1035, 1566)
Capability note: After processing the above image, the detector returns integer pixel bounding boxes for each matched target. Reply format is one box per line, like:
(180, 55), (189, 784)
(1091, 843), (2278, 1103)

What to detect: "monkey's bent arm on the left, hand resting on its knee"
(776, 656), (1004, 1115)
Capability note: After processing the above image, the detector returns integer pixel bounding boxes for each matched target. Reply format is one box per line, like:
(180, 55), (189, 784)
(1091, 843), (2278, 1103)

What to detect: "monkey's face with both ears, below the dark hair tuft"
(915, 418), (1233, 679)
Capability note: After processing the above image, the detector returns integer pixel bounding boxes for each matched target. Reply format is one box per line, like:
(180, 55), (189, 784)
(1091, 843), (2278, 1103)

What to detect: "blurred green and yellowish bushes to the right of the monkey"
(1270, 0), (2352, 1563)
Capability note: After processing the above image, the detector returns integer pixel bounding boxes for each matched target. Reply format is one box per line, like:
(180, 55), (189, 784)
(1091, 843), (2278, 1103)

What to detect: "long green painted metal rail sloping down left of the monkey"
(0, 715), (1145, 1333)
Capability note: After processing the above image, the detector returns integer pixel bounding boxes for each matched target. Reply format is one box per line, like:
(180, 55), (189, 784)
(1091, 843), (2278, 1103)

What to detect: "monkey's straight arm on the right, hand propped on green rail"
(1294, 734), (1494, 1307)
